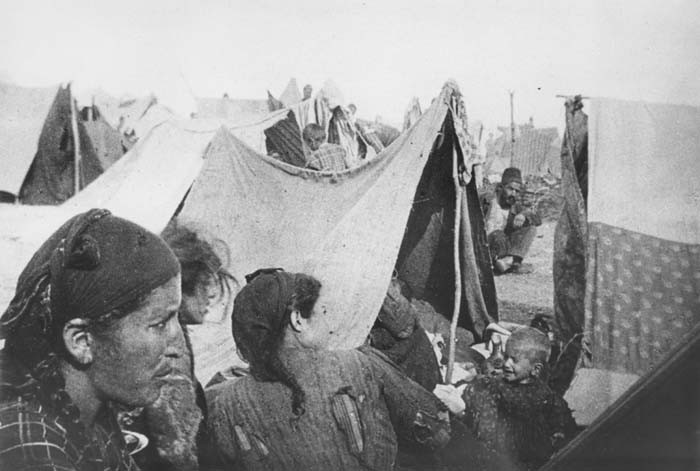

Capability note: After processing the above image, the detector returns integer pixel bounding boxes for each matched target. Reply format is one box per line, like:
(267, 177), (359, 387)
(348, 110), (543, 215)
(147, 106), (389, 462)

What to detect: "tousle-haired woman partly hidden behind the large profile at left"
(130, 220), (236, 471)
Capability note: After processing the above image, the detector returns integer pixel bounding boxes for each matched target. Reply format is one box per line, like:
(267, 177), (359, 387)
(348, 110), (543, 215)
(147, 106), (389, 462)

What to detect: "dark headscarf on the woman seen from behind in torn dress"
(231, 268), (296, 381)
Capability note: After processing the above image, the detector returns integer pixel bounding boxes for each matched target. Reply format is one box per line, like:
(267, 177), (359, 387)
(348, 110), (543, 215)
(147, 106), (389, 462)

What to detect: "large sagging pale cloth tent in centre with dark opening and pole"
(179, 86), (497, 381)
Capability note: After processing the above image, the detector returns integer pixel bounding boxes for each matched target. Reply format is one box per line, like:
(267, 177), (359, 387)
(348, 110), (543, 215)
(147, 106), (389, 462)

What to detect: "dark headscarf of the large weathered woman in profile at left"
(0, 209), (180, 368)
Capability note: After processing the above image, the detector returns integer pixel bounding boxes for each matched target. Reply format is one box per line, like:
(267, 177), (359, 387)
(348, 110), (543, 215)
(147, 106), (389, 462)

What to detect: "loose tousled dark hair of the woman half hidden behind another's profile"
(162, 219), (237, 306)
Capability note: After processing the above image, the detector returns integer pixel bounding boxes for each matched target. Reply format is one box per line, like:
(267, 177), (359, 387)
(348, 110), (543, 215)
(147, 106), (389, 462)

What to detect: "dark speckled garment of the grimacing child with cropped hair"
(462, 376), (577, 470)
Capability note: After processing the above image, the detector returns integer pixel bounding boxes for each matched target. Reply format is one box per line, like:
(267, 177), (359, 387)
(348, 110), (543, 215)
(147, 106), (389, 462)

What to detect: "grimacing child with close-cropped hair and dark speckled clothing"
(462, 327), (576, 469)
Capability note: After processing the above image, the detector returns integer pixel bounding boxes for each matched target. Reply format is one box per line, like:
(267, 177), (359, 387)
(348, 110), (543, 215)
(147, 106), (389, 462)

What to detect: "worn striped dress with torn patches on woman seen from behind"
(207, 349), (449, 470)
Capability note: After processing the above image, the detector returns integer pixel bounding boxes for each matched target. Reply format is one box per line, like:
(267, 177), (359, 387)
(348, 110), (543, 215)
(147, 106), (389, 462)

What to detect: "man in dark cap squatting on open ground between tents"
(486, 167), (542, 274)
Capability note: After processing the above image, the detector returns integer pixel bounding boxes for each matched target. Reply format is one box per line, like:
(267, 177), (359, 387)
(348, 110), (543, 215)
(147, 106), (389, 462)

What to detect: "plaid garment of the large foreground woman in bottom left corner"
(0, 351), (138, 471)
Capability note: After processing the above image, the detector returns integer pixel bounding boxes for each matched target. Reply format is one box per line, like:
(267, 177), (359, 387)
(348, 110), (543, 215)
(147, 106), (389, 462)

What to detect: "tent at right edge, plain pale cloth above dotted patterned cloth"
(554, 99), (700, 412)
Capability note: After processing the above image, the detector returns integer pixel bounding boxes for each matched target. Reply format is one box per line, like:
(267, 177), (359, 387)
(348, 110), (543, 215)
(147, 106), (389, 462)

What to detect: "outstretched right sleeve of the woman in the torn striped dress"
(361, 347), (450, 449)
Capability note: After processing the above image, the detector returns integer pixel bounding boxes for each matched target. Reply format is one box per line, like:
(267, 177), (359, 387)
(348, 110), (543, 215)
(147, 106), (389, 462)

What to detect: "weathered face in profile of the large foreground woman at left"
(87, 275), (185, 406)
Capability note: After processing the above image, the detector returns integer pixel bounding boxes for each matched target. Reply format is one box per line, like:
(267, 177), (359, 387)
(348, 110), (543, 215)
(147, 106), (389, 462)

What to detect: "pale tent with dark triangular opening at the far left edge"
(0, 84), (119, 204)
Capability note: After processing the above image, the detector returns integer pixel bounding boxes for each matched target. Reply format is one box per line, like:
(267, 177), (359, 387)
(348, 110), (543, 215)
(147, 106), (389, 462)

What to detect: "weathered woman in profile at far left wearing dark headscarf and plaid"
(0, 209), (184, 471)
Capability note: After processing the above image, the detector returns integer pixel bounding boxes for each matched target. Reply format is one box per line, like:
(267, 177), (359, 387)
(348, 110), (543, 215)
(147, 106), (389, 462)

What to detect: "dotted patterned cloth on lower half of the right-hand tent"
(585, 223), (700, 375)
